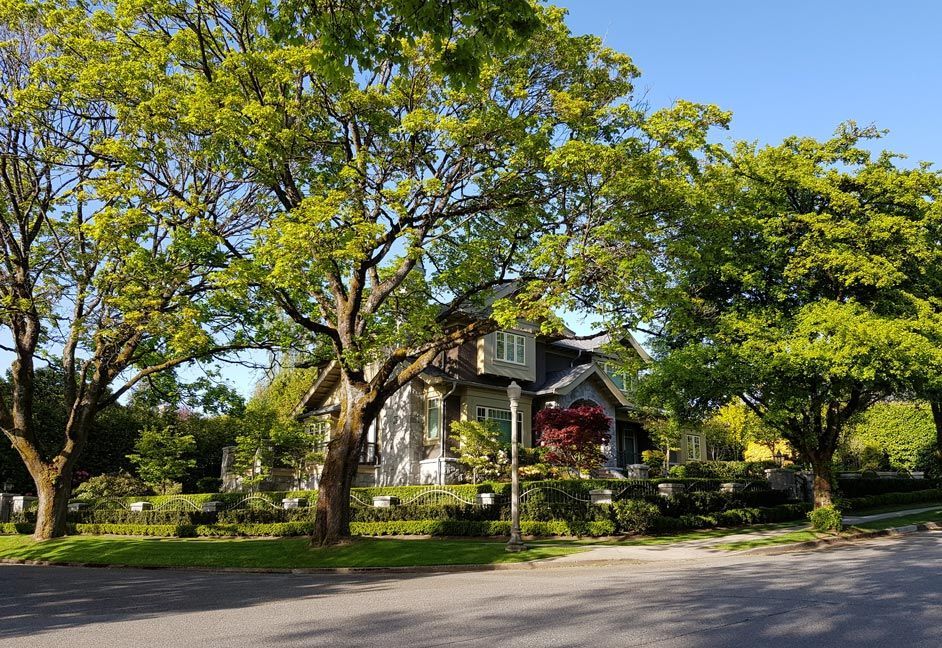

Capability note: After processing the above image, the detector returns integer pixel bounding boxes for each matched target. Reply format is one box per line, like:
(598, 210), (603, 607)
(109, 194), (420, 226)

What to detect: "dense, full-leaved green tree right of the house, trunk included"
(647, 124), (942, 506)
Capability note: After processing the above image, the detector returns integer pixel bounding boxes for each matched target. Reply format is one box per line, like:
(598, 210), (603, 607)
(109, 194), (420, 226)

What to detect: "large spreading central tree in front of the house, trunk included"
(44, 0), (725, 543)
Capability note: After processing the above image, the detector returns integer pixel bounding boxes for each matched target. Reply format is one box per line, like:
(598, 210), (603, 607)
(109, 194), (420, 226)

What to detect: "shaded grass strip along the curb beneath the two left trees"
(0, 536), (583, 569)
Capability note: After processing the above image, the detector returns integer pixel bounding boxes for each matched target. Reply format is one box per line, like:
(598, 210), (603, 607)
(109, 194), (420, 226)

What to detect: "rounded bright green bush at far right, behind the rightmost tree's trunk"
(841, 402), (936, 470)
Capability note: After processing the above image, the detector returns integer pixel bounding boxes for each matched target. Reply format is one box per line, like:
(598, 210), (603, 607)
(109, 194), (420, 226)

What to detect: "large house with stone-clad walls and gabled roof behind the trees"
(251, 324), (706, 488)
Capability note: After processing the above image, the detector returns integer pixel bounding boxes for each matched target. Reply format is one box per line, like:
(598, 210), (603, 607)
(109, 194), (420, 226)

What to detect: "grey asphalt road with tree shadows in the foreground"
(0, 534), (942, 648)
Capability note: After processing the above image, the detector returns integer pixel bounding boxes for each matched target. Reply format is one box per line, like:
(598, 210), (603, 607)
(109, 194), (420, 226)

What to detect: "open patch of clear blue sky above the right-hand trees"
(553, 0), (942, 163)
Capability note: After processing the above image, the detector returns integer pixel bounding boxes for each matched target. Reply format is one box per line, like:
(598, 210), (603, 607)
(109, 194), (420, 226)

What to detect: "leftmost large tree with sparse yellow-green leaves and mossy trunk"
(0, 1), (262, 539)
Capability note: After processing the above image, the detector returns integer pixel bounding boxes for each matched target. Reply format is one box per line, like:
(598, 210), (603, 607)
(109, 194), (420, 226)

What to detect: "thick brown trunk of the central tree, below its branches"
(311, 385), (370, 546)
